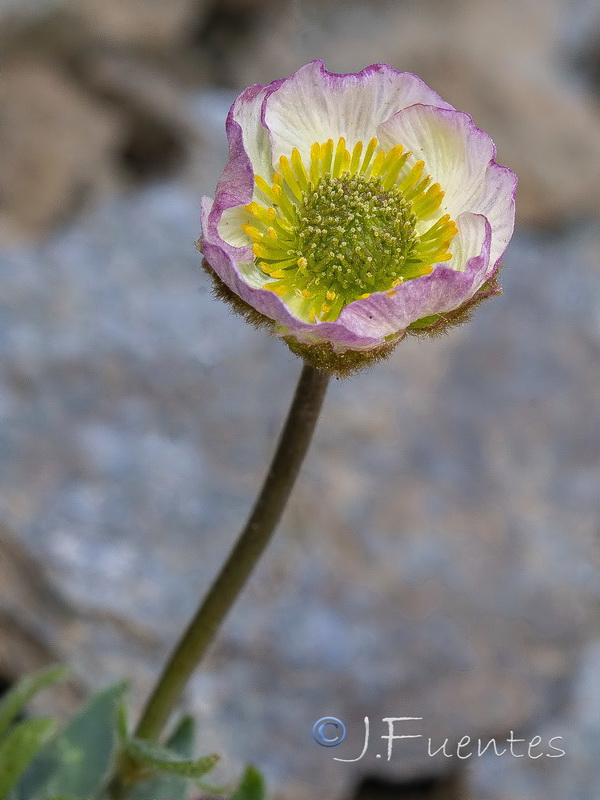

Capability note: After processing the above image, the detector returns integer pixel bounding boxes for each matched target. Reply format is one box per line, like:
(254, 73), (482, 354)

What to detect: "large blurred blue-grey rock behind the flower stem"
(0, 148), (600, 800)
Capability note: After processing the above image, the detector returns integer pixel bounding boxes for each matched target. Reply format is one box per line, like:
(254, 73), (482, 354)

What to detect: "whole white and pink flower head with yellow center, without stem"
(199, 61), (516, 374)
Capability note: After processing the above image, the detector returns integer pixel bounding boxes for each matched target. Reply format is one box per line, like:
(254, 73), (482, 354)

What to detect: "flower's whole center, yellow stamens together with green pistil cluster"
(243, 138), (457, 322)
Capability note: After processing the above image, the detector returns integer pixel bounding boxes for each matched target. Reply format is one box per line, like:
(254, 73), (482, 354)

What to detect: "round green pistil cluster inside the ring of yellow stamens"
(297, 174), (416, 306)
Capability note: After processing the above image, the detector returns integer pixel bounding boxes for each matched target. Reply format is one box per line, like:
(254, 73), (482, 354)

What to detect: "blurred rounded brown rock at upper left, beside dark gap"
(0, 56), (121, 241)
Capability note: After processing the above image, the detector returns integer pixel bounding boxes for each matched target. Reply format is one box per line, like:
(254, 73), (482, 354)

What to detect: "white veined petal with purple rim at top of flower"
(263, 61), (452, 165)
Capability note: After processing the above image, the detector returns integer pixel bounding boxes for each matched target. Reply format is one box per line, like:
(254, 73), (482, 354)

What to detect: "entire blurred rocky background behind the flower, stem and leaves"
(0, 0), (600, 800)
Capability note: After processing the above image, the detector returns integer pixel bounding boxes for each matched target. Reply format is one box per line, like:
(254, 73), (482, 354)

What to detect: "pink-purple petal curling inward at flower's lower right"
(338, 214), (491, 340)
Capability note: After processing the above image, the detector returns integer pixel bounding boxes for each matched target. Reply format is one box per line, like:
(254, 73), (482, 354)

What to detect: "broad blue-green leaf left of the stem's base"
(14, 682), (127, 800)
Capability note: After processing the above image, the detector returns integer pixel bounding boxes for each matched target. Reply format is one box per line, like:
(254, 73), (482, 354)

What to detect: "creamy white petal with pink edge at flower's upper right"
(379, 105), (516, 267)
